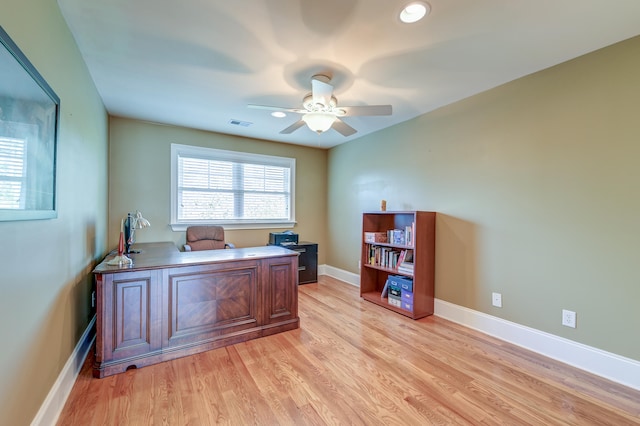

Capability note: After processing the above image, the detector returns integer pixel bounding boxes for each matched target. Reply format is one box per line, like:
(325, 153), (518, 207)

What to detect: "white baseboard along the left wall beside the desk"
(31, 316), (96, 426)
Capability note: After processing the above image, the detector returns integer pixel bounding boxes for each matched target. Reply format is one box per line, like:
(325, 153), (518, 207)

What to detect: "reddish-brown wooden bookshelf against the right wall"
(360, 211), (436, 319)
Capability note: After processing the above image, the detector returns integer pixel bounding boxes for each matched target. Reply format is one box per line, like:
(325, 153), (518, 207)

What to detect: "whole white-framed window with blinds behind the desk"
(171, 144), (295, 231)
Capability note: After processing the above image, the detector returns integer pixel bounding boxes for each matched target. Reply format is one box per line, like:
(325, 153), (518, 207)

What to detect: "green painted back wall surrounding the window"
(109, 117), (327, 264)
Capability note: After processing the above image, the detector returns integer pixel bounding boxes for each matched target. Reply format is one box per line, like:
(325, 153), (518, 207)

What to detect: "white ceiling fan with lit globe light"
(248, 74), (391, 136)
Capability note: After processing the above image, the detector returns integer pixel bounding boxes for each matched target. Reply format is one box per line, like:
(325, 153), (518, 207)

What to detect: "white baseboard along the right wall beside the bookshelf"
(321, 265), (640, 390)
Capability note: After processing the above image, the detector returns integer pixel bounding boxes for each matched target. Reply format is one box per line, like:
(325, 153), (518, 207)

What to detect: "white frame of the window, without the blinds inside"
(170, 143), (296, 231)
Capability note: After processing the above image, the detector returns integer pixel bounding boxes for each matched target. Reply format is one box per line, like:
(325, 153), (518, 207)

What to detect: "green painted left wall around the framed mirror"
(0, 0), (108, 425)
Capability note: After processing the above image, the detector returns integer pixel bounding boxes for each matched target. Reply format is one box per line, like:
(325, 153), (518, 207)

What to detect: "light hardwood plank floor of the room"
(58, 276), (640, 426)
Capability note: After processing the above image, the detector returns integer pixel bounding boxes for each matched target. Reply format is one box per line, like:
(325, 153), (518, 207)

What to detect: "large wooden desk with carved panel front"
(93, 243), (300, 377)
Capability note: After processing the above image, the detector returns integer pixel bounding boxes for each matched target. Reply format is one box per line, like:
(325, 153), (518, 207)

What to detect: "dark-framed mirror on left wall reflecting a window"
(0, 26), (60, 221)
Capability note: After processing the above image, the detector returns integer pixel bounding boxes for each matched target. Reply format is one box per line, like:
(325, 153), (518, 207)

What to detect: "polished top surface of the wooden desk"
(93, 242), (298, 274)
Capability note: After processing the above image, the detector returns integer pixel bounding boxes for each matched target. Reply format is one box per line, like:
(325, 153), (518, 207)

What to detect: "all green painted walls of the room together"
(0, 0), (640, 425)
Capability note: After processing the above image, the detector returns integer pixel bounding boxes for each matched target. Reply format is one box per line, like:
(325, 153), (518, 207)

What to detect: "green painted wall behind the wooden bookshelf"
(327, 37), (640, 360)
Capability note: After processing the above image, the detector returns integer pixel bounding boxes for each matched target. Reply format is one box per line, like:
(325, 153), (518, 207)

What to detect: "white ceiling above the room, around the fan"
(58, 0), (640, 148)
